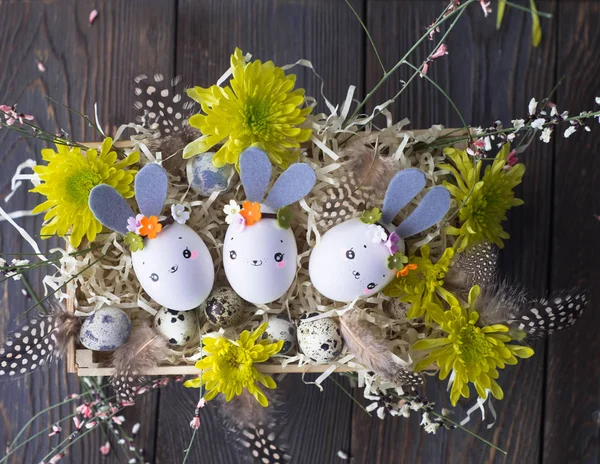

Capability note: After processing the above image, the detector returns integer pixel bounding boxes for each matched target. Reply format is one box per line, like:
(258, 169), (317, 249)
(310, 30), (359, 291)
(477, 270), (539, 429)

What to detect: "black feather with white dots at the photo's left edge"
(0, 298), (81, 377)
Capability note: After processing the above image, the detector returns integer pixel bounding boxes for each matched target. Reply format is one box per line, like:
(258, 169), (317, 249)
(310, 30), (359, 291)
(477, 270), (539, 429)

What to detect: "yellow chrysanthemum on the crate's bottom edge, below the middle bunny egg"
(184, 323), (283, 407)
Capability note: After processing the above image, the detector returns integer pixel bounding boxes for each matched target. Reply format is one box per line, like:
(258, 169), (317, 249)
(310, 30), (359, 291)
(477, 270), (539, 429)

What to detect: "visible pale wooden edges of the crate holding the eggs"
(66, 128), (466, 377)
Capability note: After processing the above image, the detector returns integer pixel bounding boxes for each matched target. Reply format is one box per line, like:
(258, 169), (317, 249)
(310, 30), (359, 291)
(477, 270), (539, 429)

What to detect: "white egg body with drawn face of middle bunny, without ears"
(223, 205), (298, 304)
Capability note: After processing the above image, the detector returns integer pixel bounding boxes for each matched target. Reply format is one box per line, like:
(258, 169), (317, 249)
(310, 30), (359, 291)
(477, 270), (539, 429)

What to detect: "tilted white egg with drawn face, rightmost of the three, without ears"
(308, 219), (404, 302)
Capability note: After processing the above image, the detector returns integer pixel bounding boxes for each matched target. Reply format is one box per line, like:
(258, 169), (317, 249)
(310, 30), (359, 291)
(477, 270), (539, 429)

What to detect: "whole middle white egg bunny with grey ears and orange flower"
(223, 147), (316, 304)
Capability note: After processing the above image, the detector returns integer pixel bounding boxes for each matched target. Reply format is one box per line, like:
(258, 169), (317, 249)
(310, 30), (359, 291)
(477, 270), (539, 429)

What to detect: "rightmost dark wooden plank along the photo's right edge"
(543, 1), (600, 463)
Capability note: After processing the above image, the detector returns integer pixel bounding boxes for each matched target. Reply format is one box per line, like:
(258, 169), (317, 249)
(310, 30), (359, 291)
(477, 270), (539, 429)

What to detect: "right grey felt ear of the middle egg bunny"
(265, 163), (317, 210)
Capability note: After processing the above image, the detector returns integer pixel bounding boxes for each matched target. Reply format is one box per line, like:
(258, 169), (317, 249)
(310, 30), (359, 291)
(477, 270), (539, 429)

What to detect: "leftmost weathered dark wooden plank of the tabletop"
(0, 0), (175, 464)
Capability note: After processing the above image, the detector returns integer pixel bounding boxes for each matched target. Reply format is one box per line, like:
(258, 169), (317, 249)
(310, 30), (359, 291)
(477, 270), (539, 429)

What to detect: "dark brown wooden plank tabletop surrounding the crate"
(0, 0), (600, 464)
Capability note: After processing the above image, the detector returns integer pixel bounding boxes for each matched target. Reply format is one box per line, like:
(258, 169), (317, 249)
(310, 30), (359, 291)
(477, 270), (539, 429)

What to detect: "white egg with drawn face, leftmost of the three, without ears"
(132, 223), (215, 311)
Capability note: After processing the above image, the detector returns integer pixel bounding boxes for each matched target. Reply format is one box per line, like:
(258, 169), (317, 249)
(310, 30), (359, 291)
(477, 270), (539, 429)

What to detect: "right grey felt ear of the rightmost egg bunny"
(396, 187), (450, 238)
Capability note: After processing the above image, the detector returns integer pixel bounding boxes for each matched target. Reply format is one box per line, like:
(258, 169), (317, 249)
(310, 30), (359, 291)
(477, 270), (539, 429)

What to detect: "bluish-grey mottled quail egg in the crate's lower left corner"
(79, 308), (131, 351)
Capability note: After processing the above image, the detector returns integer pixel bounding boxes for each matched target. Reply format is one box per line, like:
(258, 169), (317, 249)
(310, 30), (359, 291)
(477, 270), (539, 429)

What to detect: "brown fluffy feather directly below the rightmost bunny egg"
(340, 309), (423, 388)
